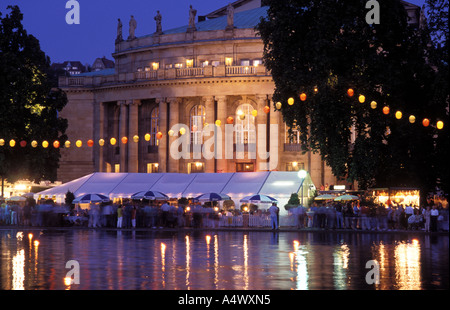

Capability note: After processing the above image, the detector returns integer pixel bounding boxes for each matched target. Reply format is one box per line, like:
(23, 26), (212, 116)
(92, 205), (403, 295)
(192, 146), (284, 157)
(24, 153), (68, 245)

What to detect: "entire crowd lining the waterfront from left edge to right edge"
(0, 196), (449, 232)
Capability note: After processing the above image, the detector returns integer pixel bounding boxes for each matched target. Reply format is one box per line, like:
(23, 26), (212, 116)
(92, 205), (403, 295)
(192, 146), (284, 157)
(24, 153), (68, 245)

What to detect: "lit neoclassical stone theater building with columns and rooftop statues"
(58, 0), (418, 187)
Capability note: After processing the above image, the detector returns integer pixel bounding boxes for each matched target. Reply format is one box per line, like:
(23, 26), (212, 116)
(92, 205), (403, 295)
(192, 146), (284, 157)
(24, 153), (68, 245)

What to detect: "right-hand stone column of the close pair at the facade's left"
(128, 100), (141, 173)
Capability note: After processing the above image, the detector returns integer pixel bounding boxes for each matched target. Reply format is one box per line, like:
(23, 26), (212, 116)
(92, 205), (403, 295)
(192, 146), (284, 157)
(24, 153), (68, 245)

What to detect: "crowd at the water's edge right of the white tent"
(290, 202), (449, 232)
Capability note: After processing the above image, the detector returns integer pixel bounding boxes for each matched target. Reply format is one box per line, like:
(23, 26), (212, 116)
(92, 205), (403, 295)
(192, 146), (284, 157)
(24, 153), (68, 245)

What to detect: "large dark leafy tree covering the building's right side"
(257, 0), (444, 194)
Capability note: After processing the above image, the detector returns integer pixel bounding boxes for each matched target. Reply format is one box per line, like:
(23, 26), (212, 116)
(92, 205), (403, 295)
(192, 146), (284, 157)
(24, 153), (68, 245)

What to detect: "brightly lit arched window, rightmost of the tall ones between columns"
(235, 103), (256, 144)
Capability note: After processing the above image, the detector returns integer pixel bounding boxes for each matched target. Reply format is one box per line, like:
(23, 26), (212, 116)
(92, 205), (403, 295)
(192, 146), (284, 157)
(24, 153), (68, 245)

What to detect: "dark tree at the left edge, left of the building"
(0, 6), (67, 182)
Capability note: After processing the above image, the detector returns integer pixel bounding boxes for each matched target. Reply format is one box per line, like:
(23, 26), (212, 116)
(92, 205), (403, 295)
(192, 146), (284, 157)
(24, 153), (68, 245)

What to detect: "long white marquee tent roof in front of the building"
(34, 171), (315, 211)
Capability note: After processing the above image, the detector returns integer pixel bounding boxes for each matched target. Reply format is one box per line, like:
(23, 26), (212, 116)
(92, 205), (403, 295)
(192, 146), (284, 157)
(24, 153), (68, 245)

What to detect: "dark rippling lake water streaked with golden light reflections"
(0, 230), (449, 290)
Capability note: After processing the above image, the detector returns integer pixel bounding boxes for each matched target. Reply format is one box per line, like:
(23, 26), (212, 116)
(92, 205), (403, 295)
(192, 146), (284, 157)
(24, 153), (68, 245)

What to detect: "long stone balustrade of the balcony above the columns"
(59, 65), (270, 87)
